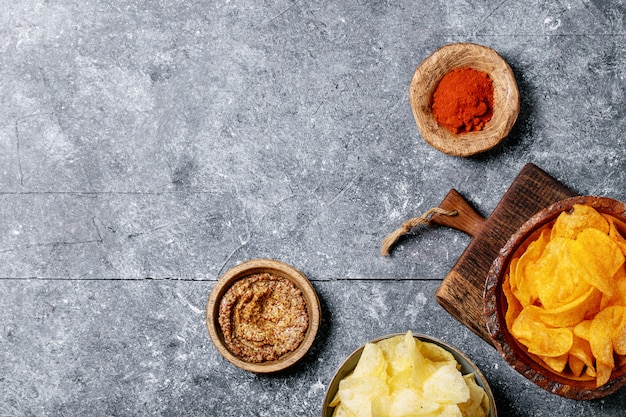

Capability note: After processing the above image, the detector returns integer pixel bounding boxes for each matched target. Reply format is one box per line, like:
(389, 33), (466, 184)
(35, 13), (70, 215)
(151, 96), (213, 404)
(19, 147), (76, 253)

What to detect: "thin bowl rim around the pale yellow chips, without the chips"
(322, 333), (498, 417)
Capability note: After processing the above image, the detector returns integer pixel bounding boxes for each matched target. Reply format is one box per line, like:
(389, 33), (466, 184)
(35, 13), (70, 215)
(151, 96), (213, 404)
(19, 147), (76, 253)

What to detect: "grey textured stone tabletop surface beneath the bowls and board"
(0, 0), (626, 417)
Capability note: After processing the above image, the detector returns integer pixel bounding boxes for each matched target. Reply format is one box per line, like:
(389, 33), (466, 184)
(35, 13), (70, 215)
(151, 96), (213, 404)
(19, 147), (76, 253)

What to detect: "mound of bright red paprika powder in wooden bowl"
(432, 68), (493, 134)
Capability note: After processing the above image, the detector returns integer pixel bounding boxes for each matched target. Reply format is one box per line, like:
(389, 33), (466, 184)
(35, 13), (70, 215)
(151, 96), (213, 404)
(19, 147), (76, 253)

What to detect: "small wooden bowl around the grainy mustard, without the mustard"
(206, 259), (322, 373)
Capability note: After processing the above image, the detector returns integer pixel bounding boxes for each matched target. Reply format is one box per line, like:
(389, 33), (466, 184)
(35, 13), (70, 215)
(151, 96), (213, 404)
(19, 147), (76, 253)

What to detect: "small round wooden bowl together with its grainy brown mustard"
(206, 259), (321, 373)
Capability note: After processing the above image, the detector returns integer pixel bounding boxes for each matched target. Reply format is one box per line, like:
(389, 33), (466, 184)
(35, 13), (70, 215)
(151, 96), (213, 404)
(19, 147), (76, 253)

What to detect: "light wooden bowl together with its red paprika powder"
(409, 43), (520, 156)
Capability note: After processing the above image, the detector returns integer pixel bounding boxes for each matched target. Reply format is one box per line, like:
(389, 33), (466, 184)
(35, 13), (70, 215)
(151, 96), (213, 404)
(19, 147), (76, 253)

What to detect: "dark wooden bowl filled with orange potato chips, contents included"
(484, 196), (626, 400)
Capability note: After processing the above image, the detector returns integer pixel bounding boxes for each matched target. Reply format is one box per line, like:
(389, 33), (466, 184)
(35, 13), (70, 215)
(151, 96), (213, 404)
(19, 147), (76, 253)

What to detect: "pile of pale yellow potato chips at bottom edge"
(330, 331), (489, 417)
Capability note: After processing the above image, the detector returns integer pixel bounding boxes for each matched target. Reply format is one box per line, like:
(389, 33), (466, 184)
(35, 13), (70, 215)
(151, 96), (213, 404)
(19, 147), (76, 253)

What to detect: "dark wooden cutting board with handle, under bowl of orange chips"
(430, 163), (576, 344)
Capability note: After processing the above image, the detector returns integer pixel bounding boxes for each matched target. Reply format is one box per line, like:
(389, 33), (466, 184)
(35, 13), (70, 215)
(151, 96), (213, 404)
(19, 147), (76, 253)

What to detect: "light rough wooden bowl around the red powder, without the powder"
(409, 43), (520, 156)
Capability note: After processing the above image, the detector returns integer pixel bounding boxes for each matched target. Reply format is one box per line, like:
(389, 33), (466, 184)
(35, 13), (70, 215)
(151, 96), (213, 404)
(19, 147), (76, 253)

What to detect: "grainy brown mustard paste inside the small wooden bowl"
(219, 273), (309, 363)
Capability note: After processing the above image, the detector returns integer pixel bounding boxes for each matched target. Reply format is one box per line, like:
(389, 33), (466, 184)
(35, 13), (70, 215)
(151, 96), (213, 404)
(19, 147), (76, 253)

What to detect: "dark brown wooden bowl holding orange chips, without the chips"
(483, 196), (626, 400)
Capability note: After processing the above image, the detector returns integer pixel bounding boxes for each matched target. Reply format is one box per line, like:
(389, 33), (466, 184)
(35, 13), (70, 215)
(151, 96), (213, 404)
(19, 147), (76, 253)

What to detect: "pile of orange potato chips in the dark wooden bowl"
(502, 205), (626, 387)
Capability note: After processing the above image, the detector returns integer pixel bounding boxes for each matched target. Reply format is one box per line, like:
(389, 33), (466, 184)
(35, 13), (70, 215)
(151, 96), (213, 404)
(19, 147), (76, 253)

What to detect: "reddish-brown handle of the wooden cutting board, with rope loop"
(430, 188), (485, 238)
